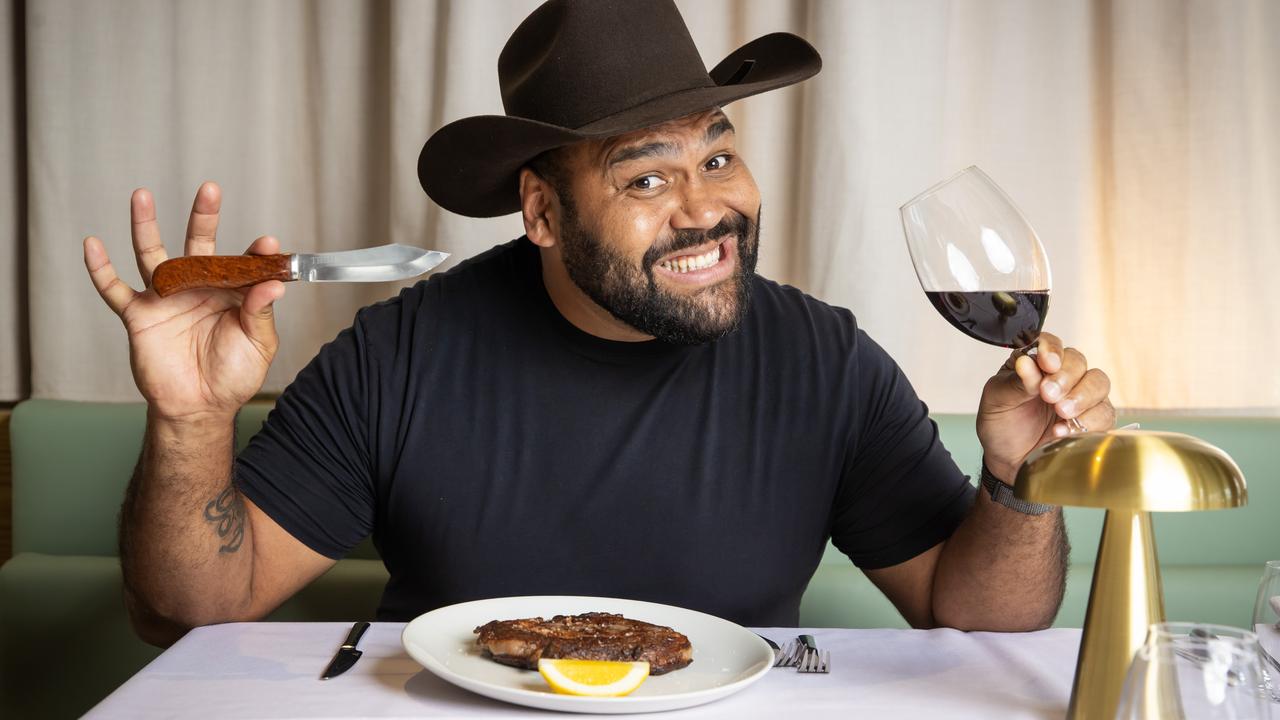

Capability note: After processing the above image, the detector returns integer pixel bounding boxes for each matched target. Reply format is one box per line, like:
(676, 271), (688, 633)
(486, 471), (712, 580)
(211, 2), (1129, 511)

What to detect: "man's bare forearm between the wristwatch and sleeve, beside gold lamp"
(867, 489), (1070, 632)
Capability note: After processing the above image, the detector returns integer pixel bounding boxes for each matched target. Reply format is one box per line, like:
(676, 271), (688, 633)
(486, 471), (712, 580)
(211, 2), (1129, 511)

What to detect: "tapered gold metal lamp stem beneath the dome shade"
(1066, 510), (1165, 720)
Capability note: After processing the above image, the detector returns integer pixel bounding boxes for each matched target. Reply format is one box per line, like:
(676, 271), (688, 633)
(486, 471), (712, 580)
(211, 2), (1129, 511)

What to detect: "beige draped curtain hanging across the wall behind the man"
(0, 0), (1280, 413)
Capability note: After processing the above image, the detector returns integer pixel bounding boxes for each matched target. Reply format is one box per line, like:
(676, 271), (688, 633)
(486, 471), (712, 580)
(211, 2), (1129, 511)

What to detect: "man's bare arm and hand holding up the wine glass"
(868, 333), (1116, 632)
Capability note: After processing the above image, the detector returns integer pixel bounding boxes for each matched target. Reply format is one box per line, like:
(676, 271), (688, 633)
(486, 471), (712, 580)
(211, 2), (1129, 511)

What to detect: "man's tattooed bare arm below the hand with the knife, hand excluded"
(120, 411), (333, 646)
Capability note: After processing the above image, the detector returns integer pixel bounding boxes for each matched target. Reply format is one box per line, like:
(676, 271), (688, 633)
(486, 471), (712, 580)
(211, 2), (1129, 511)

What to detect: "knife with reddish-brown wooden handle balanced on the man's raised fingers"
(151, 243), (449, 297)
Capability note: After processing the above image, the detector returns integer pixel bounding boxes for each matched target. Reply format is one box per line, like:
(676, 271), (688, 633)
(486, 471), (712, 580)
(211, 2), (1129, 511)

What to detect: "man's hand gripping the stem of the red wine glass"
(978, 333), (1116, 484)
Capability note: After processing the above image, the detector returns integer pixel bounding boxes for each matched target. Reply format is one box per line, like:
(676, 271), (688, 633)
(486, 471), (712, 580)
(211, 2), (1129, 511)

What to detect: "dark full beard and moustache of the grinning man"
(561, 196), (760, 345)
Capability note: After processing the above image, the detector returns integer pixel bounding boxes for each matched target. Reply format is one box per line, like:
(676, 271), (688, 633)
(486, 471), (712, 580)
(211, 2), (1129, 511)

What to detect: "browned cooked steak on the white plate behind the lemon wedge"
(475, 612), (694, 675)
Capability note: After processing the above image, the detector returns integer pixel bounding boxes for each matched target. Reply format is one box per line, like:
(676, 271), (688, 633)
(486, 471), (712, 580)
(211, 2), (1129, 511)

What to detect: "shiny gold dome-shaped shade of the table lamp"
(1014, 430), (1248, 512)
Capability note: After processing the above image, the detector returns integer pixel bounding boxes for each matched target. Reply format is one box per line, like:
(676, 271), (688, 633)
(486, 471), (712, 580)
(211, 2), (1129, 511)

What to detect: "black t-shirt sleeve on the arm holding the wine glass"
(832, 331), (975, 570)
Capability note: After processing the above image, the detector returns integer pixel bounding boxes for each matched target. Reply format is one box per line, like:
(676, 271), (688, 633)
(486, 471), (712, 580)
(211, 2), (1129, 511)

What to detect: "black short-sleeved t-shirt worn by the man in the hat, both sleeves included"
(236, 238), (973, 625)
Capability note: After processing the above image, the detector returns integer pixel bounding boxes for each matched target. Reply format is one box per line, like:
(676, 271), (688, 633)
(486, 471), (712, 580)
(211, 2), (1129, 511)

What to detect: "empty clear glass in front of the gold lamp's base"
(1116, 623), (1271, 720)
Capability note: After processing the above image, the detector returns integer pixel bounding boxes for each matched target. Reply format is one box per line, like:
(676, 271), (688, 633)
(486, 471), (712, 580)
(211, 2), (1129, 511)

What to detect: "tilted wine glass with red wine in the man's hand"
(900, 165), (1084, 432)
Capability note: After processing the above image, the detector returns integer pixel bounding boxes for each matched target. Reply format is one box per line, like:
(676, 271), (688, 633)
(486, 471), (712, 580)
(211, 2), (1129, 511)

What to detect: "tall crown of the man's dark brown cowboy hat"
(498, 0), (716, 128)
